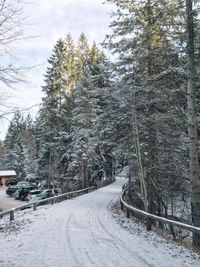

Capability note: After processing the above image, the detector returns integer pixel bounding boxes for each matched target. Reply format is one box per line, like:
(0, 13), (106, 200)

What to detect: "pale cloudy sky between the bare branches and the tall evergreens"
(0, 0), (112, 139)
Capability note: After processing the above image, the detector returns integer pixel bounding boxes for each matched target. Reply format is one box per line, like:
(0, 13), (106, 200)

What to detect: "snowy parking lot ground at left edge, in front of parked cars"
(0, 187), (24, 211)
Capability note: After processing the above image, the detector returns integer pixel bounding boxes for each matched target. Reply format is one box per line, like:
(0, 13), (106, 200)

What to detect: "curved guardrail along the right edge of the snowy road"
(120, 189), (200, 234)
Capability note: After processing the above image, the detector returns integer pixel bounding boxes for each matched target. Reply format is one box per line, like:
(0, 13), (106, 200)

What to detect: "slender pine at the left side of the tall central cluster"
(37, 40), (66, 183)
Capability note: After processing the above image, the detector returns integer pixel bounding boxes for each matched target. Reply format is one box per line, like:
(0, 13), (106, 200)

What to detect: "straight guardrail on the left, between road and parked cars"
(0, 186), (95, 221)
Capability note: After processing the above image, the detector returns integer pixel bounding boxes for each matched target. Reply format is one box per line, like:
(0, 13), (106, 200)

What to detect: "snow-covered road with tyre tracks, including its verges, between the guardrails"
(0, 178), (200, 267)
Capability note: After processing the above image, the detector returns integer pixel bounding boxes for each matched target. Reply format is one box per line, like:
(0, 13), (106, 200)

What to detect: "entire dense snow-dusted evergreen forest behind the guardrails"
(0, 0), (200, 246)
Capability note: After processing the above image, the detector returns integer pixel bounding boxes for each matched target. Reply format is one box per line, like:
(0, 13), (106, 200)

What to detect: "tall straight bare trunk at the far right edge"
(186, 0), (200, 247)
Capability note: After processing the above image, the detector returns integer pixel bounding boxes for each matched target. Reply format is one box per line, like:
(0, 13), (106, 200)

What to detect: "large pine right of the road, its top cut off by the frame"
(106, 0), (188, 228)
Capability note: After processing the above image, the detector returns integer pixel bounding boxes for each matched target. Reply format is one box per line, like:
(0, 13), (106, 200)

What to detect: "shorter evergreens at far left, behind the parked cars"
(1, 111), (35, 179)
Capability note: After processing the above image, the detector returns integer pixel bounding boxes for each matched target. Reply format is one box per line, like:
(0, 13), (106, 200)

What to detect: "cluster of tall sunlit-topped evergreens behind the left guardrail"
(33, 33), (114, 193)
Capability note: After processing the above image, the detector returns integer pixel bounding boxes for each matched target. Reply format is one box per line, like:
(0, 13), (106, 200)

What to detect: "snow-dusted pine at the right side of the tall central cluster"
(70, 49), (112, 186)
